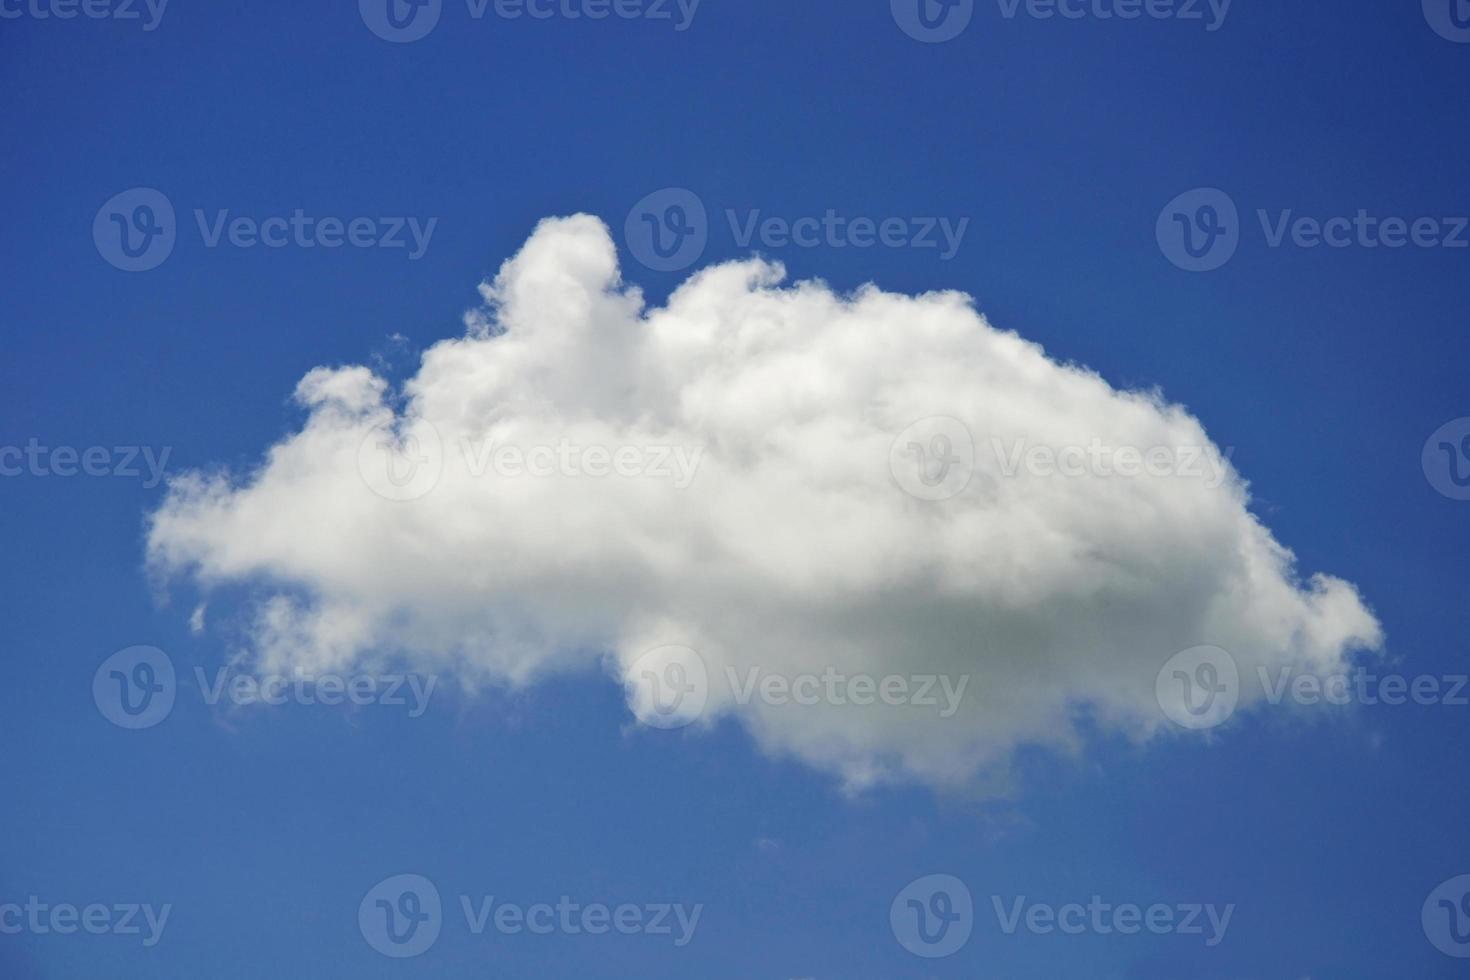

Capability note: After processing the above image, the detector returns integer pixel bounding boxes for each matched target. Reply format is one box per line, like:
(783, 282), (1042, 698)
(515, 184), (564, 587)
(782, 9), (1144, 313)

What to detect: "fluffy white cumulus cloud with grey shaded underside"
(148, 215), (1380, 788)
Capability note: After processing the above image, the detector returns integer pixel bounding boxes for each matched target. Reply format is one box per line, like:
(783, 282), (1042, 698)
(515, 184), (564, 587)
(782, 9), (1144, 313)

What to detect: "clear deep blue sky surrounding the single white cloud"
(0, 0), (1470, 980)
